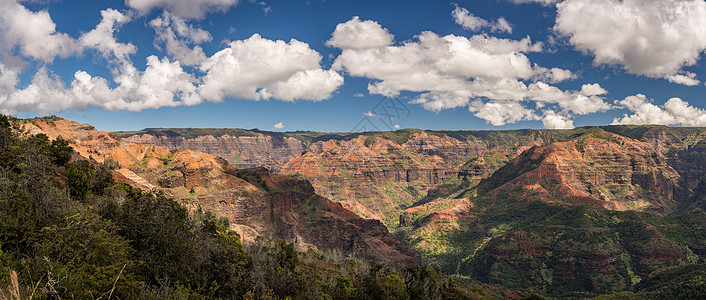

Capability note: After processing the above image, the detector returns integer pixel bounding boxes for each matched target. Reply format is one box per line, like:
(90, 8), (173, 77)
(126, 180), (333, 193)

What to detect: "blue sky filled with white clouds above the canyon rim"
(0, 0), (706, 131)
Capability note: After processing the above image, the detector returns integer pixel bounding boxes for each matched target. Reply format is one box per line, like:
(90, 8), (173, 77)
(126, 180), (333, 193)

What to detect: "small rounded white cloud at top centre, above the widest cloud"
(326, 16), (394, 49)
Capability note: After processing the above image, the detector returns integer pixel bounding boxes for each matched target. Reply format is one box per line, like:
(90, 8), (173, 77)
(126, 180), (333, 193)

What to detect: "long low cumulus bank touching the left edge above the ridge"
(0, 56), (201, 114)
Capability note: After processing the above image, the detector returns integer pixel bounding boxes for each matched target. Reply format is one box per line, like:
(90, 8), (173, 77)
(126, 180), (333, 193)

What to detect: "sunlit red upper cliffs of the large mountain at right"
(400, 128), (706, 246)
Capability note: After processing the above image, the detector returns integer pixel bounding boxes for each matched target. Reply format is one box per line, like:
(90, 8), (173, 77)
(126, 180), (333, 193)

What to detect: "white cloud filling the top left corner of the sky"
(0, 0), (81, 62)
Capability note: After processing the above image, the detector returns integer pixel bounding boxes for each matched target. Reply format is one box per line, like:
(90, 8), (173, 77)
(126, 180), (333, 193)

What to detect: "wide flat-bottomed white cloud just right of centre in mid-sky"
(333, 32), (545, 96)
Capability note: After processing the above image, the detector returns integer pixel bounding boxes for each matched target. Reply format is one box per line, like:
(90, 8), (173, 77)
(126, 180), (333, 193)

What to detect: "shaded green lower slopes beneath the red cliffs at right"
(403, 185), (706, 298)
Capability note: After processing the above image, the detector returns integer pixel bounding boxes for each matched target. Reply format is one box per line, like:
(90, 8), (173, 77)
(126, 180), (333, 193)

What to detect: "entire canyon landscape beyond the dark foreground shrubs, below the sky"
(2, 118), (706, 298)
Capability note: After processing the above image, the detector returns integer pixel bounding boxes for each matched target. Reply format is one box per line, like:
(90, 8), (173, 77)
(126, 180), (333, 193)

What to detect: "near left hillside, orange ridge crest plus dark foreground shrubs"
(0, 115), (478, 299)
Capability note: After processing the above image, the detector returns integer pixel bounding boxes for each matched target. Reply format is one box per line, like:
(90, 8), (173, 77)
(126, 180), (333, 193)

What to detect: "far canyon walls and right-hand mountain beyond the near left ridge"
(118, 126), (706, 297)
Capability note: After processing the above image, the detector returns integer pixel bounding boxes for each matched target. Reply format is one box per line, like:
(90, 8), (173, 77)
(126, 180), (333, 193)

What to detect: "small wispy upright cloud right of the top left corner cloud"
(79, 8), (137, 62)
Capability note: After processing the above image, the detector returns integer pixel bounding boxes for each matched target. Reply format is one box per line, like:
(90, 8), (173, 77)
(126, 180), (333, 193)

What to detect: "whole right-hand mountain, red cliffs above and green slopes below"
(401, 127), (706, 297)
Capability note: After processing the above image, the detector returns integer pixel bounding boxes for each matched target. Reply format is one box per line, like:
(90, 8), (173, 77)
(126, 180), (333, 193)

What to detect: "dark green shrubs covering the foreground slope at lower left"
(0, 116), (484, 299)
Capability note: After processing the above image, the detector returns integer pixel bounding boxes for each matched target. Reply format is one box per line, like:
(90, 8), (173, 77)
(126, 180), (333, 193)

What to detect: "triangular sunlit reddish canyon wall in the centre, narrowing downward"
(282, 131), (536, 228)
